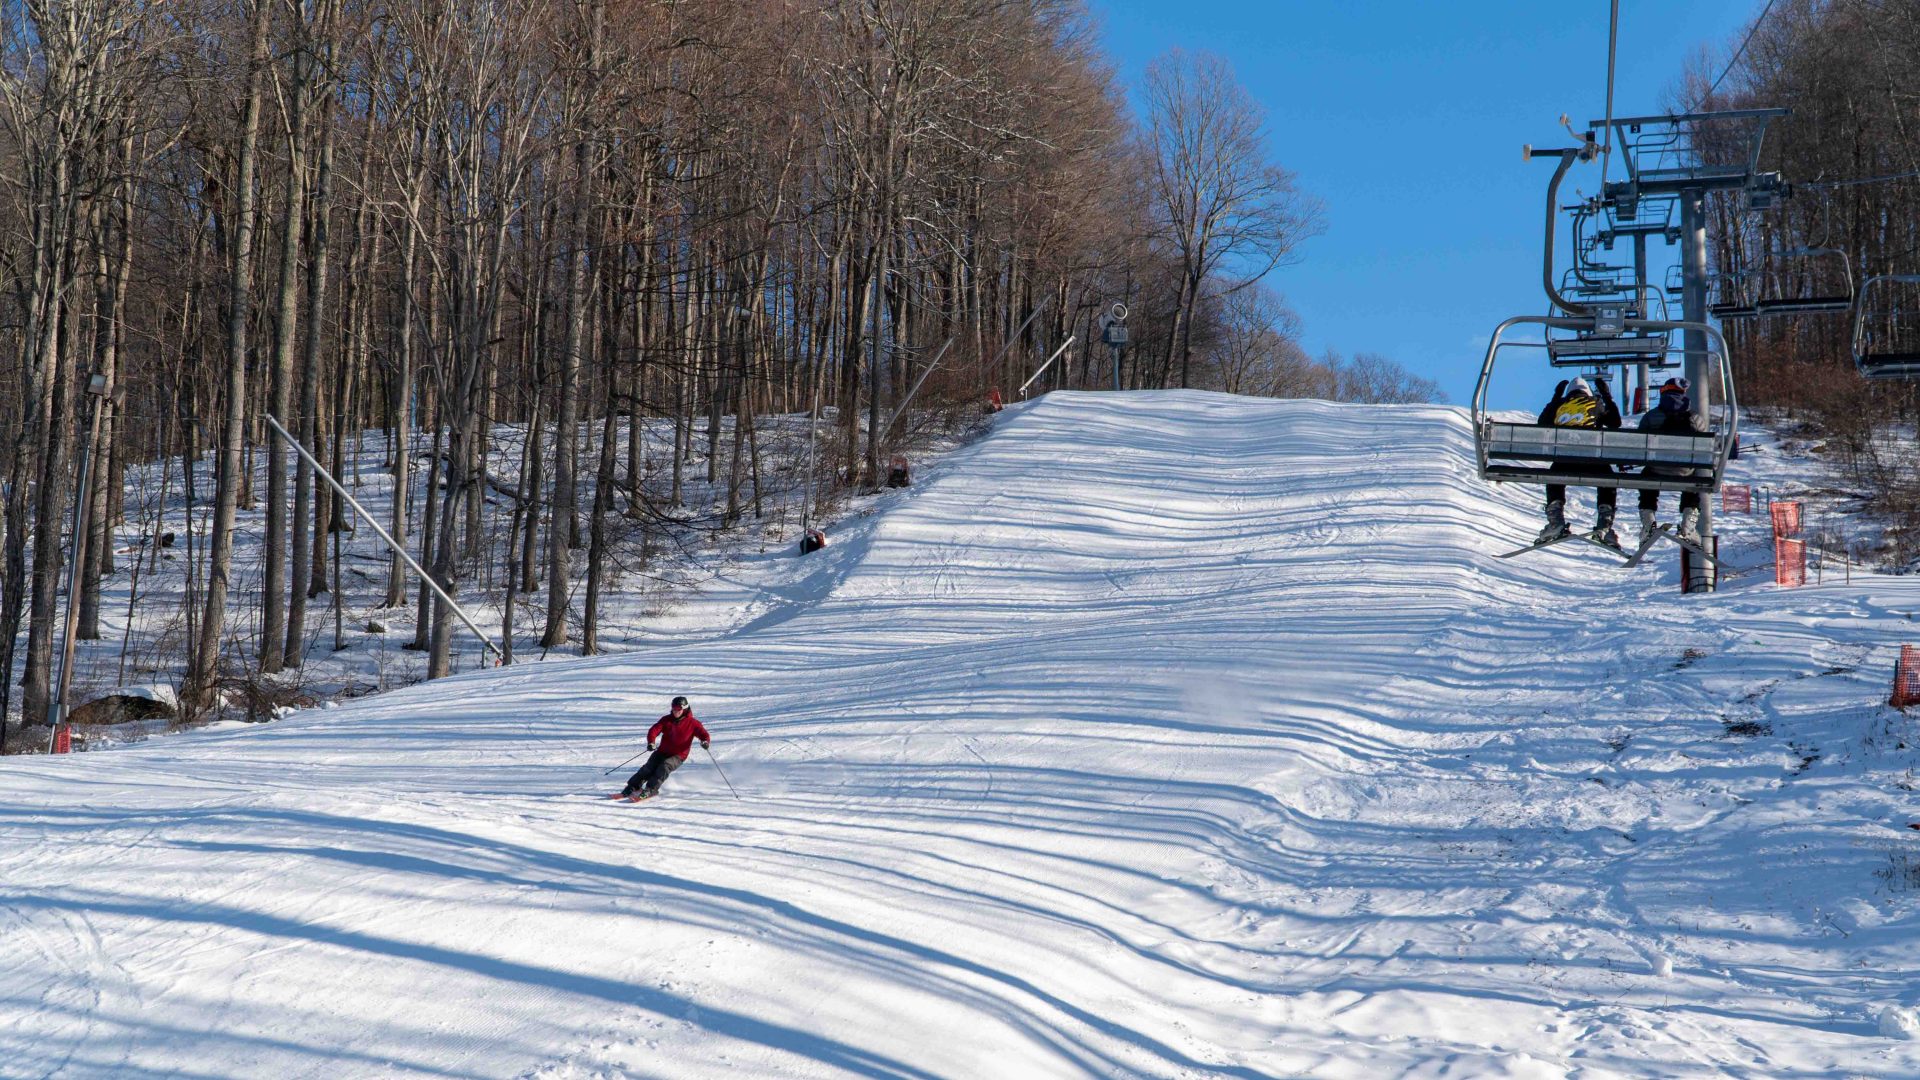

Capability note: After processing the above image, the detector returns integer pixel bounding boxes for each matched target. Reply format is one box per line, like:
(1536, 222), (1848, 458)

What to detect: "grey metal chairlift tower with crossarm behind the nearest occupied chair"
(1589, 110), (1789, 592)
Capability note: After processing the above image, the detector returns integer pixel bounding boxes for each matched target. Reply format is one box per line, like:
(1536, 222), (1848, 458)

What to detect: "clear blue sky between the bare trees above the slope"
(1089, 0), (1761, 405)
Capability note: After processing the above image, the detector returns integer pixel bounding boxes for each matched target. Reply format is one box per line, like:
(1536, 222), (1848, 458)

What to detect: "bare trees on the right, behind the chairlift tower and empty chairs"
(1680, 0), (1920, 428)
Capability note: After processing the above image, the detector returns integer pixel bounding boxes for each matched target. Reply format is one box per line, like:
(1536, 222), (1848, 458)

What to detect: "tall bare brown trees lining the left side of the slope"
(0, 0), (1315, 740)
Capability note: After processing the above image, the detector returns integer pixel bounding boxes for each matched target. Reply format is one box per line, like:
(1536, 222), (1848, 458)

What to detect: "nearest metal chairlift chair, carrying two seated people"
(1473, 313), (1735, 492)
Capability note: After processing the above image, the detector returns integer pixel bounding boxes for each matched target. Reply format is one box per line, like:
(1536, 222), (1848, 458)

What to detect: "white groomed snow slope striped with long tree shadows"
(0, 392), (1920, 1078)
